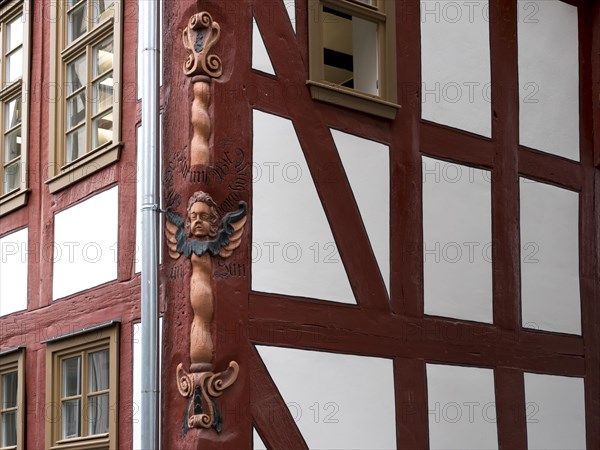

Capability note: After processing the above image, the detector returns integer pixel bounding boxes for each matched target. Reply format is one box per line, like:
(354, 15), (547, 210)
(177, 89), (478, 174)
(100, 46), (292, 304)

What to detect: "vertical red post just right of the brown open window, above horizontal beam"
(390, 0), (423, 317)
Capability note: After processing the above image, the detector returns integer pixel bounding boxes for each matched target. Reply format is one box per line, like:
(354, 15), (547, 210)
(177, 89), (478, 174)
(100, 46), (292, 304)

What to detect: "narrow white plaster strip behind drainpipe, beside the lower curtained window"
(131, 317), (163, 450)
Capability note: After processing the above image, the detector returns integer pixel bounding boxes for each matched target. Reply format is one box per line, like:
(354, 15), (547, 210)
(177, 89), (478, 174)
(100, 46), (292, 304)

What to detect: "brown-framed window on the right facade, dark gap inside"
(307, 0), (398, 118)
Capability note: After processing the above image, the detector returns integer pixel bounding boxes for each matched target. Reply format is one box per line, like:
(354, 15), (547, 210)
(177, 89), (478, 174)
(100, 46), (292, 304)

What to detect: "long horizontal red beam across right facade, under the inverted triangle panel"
(249, 294), (585, 376)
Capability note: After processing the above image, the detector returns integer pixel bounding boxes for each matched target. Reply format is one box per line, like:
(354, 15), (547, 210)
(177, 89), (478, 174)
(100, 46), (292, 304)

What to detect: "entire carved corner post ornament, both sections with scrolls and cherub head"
(170, 12), (238, 434)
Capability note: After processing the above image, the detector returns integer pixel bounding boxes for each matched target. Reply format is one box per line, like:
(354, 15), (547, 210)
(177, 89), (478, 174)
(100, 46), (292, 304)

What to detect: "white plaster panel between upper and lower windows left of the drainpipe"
(52, 186), (119, 300)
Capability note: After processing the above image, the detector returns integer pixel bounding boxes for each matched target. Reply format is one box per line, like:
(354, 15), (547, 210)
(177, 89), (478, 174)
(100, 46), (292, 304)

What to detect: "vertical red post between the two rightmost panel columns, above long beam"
(490, 2), (521, 330)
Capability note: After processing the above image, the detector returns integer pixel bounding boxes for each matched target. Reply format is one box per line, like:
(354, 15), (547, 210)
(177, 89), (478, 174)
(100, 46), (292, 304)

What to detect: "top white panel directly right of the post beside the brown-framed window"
(420, 0), (491, 137)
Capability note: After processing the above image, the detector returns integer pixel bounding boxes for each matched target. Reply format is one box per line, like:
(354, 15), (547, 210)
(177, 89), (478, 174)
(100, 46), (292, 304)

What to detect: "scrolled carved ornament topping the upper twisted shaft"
(183, 11), (223, 78)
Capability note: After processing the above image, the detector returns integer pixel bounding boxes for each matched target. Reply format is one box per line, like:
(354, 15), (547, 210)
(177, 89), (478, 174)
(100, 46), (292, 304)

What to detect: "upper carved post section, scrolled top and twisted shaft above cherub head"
(183, 12), (223, 166)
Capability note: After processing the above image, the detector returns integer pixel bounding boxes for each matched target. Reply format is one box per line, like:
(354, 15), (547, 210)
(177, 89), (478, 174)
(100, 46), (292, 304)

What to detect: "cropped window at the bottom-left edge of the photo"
(0, 348), (25, 450)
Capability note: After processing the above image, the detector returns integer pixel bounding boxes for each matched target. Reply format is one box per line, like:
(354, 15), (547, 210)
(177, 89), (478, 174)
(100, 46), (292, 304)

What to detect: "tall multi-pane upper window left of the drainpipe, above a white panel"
(48, 0), (122, 192)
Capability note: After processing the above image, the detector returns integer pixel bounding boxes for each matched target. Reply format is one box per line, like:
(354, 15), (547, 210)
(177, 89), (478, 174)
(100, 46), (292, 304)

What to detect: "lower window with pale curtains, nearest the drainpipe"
(46, 323), (118, 449)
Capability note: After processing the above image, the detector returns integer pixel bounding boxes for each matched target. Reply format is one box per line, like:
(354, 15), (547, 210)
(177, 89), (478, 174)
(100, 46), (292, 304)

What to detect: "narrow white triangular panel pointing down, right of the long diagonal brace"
(331, 130), (390, 294)
